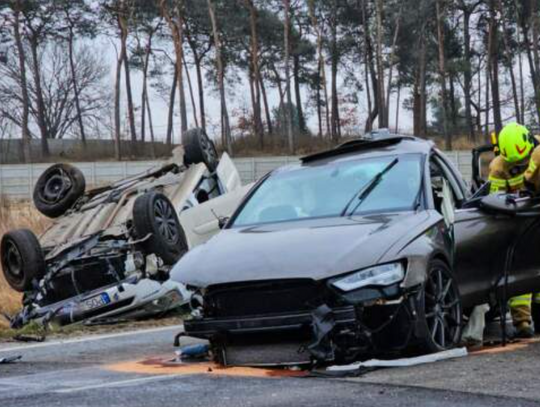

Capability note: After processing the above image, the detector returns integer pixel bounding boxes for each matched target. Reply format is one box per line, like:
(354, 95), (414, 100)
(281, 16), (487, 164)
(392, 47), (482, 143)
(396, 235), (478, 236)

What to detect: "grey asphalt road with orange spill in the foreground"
(0, 327), (540, 407)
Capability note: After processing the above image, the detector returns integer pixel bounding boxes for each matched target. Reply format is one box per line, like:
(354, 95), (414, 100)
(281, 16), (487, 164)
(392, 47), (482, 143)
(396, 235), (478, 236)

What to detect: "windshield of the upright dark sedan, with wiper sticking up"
(233, 154), (422, 226)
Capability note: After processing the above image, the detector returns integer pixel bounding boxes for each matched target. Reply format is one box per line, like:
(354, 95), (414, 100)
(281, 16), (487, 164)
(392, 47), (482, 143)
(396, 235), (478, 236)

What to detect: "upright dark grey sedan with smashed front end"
(173, 135), (540, 365)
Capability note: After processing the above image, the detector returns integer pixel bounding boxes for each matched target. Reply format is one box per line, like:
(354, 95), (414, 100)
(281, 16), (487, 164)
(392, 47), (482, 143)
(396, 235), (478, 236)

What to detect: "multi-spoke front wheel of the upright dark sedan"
(415, 260), (463, 354)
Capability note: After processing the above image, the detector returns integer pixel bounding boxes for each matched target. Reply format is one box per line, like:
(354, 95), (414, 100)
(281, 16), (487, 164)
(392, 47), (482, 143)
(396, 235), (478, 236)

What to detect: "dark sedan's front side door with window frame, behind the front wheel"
(430, 155), (515, 307)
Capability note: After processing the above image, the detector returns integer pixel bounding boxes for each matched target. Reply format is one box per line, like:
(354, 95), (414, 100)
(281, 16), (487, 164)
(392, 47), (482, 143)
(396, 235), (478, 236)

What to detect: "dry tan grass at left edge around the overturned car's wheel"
(0, 197), (48, 331)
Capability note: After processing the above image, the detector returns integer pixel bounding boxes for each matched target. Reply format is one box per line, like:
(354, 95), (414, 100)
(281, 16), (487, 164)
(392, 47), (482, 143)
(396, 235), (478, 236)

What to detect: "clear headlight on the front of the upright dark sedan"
(331, 263), (405, 291)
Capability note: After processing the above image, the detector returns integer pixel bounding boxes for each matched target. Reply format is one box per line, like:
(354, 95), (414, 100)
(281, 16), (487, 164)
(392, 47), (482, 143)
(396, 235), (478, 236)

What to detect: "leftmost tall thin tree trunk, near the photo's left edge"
(13, 0), (32, 163)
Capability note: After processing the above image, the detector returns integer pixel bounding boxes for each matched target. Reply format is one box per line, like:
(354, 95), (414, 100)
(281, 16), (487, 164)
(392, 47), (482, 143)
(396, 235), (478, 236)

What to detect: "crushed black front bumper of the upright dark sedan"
(184, 298), (414, 366)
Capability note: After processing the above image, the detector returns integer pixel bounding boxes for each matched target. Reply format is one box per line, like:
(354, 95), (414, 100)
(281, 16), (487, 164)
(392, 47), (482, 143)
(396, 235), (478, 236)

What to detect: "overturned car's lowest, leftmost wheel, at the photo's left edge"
(0, 229), (46, 292)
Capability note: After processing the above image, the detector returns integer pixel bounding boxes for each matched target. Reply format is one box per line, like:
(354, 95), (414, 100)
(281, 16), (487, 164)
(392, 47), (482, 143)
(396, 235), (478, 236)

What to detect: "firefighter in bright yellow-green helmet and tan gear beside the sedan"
(489, 123), (540, 338)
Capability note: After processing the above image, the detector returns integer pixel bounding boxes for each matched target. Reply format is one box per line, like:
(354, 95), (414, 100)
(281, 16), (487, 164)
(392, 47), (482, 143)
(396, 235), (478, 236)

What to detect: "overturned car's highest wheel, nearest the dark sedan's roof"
(182, 128), (219, 172)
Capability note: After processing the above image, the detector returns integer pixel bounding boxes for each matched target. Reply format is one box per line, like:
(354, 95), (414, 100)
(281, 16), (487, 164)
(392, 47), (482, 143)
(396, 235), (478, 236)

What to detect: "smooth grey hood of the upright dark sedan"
(172, 212), (429, 288)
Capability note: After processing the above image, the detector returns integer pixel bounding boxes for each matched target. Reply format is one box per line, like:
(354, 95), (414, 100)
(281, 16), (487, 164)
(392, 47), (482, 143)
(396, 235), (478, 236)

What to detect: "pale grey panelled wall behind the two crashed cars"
(0, 151), (472, 200)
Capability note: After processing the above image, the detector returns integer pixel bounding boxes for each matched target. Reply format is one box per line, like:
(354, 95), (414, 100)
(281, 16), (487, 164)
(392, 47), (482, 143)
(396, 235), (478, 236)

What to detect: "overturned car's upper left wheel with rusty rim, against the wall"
(33, 164), (86, 218)
